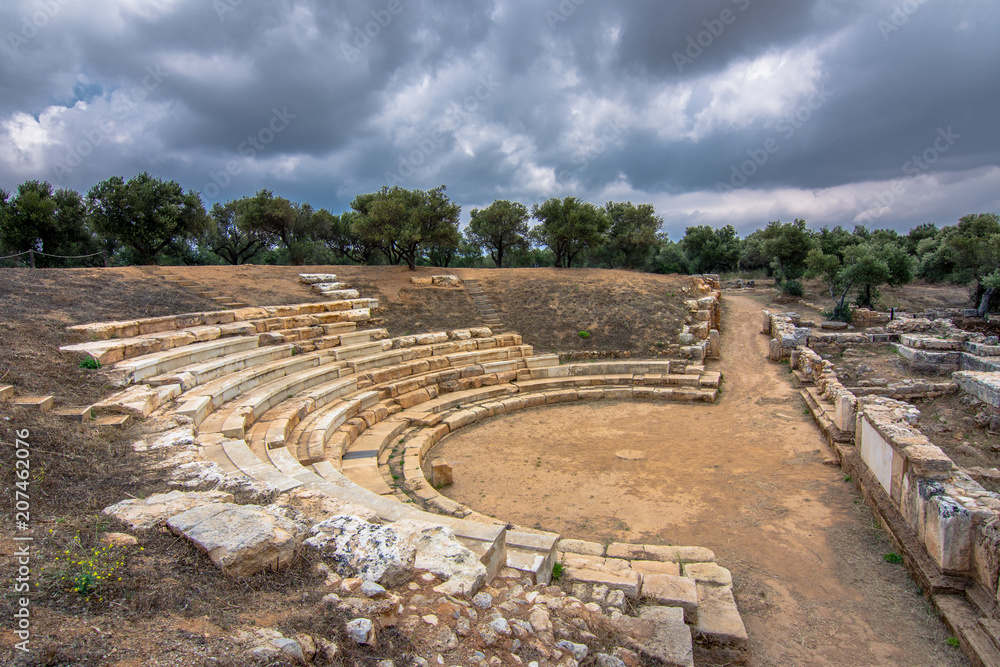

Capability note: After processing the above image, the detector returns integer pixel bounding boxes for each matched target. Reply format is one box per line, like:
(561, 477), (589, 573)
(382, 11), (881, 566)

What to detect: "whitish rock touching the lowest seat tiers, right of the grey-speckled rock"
(392, 519), (487, 596)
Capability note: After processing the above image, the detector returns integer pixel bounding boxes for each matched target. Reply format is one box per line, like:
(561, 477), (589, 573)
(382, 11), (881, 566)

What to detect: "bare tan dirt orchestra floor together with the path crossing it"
(431, 294), (967, 666)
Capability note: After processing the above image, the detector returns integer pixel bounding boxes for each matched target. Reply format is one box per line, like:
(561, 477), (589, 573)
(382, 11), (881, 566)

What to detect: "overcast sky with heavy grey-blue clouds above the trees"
(0, 0), (1000, 239)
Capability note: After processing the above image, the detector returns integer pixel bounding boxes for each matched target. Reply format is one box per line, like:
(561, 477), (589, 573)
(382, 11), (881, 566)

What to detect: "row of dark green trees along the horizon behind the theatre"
(0, 172), (1000, 318)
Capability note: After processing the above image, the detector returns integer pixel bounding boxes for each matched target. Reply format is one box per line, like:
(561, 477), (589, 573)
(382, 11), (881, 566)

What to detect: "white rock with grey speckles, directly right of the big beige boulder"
(303, 516), (416, 587)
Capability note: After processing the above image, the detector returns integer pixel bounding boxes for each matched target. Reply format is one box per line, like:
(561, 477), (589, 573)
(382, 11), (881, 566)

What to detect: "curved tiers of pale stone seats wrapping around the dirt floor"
(62, 284), (720, 582)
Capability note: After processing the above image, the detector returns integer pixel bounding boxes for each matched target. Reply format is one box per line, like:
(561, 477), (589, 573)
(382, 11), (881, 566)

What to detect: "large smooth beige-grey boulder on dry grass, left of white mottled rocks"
(167, 503), (307, 577)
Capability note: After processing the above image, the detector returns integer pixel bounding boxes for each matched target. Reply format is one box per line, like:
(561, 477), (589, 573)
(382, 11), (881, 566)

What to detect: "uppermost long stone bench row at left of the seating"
(59, 299), (378, 365)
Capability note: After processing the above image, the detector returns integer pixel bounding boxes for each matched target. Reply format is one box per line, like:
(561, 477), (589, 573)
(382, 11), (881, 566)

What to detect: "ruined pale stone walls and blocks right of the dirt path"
(763, 311), (1000, 601)
